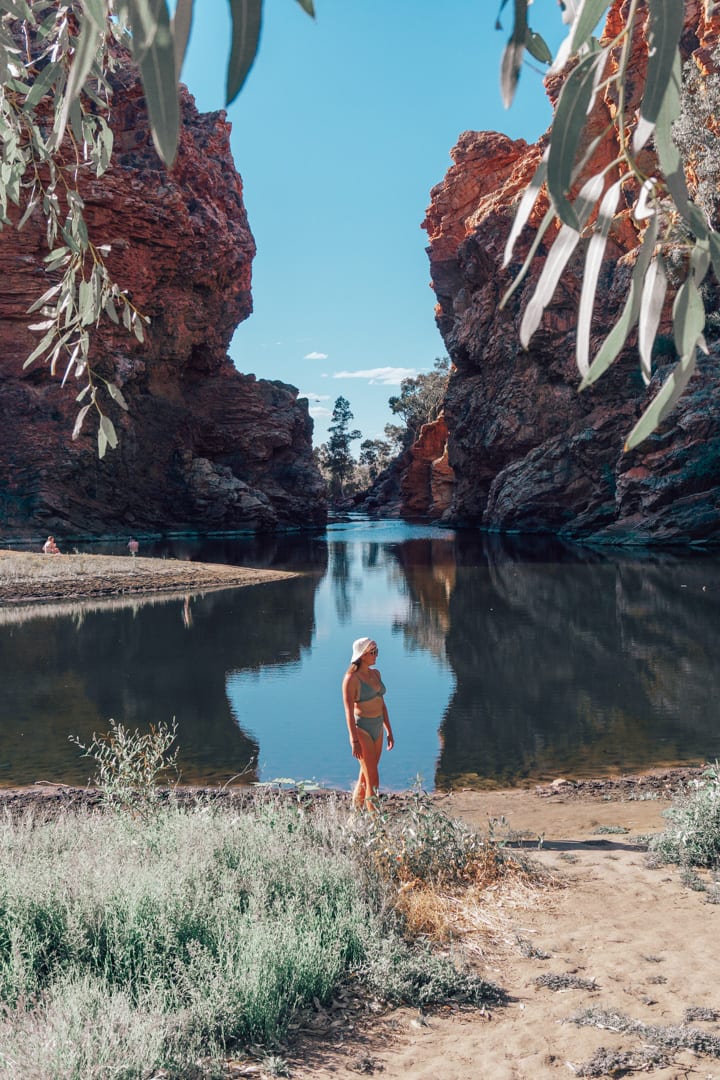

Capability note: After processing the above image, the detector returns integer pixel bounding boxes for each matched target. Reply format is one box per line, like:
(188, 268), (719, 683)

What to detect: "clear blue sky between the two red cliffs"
(181, 0), (565, 454)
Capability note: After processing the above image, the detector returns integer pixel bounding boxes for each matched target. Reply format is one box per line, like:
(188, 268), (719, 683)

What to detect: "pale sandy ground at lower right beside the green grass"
(286, 788), (720, 1080)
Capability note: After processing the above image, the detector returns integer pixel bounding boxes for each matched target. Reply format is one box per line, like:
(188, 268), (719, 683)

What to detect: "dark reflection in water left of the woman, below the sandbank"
(0, 575), (316, 785)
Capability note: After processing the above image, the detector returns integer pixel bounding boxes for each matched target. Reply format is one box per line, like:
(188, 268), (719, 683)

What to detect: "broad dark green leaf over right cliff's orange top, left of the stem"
(547, 50), (607, 229)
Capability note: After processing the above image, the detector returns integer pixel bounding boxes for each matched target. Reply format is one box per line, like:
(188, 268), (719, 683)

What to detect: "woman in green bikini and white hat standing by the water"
(342, 637), (395, 809)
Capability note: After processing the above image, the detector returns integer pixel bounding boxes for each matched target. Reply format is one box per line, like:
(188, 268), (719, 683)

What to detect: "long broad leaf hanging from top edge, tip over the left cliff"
(131, 0), (180, 168)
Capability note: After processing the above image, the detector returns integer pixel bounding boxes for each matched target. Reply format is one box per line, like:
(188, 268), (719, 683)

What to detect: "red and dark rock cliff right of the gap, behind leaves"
(416, 0), (720, 542)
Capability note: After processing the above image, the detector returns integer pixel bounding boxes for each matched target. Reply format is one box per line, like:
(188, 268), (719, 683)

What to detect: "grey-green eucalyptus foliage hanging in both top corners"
(0, 0), (720, 456)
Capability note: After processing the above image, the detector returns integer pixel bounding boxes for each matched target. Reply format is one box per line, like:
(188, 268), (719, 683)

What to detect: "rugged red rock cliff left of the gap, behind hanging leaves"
(0, 67), (326, 538)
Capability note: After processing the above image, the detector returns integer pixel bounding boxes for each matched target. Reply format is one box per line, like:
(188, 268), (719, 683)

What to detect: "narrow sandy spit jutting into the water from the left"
(0, 549), (298, 609)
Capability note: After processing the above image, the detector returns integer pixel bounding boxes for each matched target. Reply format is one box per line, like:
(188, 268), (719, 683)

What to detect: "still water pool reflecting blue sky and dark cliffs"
(0, 518), (720, 789)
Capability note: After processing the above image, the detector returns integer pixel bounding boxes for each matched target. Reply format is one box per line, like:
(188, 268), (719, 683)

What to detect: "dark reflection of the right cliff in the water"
(429, 535), (720, 787)
